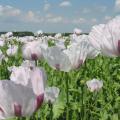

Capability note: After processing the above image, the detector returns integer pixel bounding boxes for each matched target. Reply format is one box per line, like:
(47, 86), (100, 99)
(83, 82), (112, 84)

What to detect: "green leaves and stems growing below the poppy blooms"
(0, 38), (120, 120)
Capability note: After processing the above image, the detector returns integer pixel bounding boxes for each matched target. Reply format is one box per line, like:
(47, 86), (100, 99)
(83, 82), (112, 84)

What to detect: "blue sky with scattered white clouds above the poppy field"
(0, 0), (120, 32)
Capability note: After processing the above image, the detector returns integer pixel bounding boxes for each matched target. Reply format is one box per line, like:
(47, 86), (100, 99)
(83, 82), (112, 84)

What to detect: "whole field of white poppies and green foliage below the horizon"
(0, 16), (120, 120)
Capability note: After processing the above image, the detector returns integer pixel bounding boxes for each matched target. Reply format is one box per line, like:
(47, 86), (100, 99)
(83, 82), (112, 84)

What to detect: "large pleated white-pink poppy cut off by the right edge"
(89, 16), (120, 57)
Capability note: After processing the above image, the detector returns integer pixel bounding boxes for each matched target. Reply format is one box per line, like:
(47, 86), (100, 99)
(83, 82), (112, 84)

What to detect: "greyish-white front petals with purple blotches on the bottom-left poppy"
(0, 80), (44, 119)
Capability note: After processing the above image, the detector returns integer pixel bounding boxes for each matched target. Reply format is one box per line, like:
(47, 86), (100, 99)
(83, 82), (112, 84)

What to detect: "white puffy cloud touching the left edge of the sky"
(0, 5), (21, 16)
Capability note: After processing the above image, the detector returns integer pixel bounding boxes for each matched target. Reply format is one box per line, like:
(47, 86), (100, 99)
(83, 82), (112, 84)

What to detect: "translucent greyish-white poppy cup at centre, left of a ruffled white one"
(42, 46), (71, 72)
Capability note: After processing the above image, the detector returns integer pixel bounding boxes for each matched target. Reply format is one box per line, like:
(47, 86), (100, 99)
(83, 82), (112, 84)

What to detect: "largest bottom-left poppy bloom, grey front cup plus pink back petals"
(0, 67), (46, 119)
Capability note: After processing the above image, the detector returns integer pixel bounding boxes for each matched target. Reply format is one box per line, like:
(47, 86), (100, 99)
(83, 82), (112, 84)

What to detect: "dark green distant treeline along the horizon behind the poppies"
(0, 31), (88, 37)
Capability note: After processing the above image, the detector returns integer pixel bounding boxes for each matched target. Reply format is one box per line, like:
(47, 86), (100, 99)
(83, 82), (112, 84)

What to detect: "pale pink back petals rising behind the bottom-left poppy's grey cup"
(10, 66), (47, 95)
